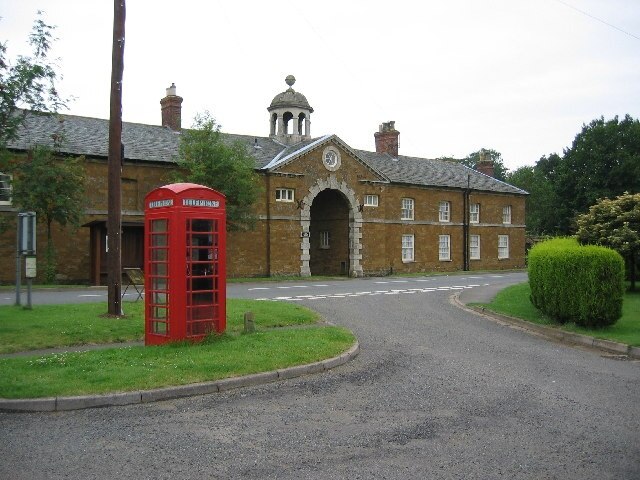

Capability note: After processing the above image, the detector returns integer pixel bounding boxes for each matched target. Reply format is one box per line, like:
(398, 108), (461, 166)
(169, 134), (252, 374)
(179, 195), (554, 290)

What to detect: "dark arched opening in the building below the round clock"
(309, 189), (349, 275)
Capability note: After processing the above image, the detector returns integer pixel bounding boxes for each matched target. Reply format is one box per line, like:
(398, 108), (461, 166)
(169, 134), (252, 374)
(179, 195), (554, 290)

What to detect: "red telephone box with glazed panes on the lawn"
(144, 183), (227, 345)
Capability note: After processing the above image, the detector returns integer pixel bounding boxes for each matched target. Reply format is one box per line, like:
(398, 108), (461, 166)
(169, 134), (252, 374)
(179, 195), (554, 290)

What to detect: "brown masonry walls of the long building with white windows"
(0, 145), (525, 283)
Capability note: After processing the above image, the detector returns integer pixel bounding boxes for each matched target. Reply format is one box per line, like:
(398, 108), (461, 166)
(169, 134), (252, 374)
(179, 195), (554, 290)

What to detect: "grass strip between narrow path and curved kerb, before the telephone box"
(0, 326), (354, 398)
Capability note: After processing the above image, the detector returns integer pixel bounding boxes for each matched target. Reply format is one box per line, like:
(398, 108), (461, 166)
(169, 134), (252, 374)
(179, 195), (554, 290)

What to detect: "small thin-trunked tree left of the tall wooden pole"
(11, 145), (85, 283)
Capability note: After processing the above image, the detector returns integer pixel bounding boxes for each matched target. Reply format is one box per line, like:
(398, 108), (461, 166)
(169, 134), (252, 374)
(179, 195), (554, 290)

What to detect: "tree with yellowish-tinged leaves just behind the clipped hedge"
(577, 192), (640, 290)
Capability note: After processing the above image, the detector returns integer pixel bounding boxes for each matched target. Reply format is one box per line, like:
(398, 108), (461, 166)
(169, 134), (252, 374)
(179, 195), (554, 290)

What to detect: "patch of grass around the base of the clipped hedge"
(475, 282), (640, 346)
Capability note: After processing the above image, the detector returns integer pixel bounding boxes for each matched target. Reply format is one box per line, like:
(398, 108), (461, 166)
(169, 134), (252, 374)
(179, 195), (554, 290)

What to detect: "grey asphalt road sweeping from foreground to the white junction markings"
(0, 274), (640, 480)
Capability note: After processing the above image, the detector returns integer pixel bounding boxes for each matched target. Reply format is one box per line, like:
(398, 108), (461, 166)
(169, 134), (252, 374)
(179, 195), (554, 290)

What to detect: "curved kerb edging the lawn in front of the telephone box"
(0, 341), (360, 412)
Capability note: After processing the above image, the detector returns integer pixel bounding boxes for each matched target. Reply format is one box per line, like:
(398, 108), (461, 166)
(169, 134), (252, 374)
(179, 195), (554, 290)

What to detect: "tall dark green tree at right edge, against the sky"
(553, 115), (640, 233)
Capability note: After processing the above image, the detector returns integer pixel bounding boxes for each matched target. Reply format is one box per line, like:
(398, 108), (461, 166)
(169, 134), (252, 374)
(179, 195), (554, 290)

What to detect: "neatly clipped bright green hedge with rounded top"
(529, 238), (624, 327)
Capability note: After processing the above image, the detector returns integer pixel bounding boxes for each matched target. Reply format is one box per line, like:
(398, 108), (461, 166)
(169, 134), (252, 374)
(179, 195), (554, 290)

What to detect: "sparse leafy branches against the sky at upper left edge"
(0, 12), (67, 149)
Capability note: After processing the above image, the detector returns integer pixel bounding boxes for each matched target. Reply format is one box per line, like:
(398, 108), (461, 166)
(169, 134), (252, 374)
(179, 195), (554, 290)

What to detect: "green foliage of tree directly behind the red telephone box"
(176, 112), (260, 230)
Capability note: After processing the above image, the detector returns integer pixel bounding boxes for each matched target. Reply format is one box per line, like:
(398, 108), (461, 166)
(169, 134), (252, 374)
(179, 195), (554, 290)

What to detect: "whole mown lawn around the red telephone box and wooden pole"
(0, 300), (355, 398)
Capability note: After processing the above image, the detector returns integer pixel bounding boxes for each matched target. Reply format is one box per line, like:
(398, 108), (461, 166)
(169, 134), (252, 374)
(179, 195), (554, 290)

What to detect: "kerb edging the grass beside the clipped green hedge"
(451, 293), (640, 359)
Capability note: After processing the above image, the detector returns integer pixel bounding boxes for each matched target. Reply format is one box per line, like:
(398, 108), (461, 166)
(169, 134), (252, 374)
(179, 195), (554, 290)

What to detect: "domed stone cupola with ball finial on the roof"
(267, 75), (313, 145)
